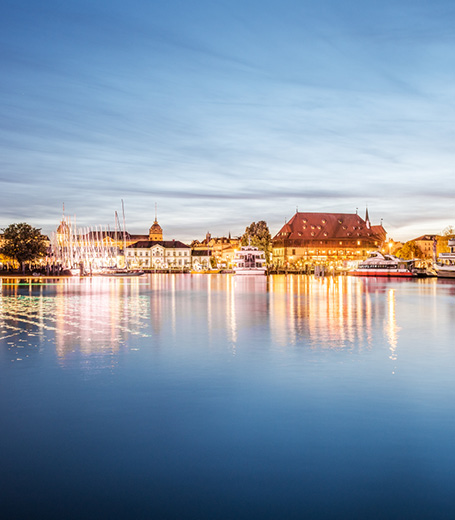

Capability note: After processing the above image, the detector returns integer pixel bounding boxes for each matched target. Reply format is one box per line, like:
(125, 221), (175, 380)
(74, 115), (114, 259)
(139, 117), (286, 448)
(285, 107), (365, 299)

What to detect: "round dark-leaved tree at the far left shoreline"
(0, 222), (47, 271)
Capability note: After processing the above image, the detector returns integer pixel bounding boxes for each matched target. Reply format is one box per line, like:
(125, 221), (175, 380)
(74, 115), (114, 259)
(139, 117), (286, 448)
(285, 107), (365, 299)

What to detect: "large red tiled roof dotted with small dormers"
(274, 213), (385, 240)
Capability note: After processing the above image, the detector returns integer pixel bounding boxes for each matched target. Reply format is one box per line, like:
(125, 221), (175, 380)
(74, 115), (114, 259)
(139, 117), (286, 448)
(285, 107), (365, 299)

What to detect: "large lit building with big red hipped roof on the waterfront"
(273, 210), (386, 265)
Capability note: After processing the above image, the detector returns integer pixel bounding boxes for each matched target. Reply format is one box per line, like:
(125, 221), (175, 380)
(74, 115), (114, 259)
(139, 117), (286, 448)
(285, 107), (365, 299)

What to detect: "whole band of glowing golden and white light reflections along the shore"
(0, 275), (453, 365)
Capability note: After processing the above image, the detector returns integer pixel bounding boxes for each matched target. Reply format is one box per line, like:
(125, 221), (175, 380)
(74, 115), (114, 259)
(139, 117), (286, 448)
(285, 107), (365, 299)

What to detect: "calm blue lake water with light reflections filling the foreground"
(0, 275), (455, 519)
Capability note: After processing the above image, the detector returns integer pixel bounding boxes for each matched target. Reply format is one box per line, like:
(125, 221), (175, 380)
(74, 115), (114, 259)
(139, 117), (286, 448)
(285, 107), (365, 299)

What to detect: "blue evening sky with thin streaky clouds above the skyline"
(0, 0), (455, 241)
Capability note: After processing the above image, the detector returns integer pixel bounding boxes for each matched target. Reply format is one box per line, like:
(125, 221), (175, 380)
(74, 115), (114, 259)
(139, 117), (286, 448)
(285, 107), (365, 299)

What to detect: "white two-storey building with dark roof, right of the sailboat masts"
(126, 240), (191, 269)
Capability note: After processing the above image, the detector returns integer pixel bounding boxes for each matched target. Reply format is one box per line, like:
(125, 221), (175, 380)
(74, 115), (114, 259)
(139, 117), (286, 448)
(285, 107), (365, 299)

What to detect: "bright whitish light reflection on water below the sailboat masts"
(0, 278), (150, 368)
